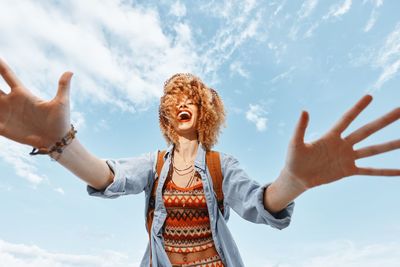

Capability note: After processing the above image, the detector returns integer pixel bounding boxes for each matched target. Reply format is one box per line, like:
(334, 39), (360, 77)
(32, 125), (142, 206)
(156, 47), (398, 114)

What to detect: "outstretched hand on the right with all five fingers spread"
(285, 95), (400, 188)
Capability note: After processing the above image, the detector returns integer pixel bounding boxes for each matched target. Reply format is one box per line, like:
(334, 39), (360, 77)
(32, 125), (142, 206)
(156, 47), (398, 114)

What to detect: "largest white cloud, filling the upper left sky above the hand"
(0, 0), (198, 112)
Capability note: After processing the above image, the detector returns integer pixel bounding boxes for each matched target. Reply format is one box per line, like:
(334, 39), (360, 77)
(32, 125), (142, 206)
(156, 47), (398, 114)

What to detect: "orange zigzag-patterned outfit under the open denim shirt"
(163, 172), (224, 267)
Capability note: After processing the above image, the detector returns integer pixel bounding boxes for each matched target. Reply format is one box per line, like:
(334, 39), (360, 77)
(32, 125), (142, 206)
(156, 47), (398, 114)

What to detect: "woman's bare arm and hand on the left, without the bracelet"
(0, 59), (113, 190)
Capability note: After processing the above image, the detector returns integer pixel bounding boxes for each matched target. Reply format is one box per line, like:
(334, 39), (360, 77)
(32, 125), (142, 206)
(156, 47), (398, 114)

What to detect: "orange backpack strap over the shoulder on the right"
(206, 151), (224, 213)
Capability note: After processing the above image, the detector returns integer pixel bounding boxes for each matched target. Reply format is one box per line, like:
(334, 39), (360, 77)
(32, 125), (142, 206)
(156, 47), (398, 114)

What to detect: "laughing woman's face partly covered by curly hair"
(175, 96), (198, 138)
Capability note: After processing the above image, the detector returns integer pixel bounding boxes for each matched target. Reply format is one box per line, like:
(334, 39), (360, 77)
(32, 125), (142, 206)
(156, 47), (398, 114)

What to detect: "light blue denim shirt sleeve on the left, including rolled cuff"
(87, 152), (157, 198)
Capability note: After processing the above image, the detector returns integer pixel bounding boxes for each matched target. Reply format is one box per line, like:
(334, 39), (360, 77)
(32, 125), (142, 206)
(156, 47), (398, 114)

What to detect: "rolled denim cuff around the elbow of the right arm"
(256, 183), (294, 230)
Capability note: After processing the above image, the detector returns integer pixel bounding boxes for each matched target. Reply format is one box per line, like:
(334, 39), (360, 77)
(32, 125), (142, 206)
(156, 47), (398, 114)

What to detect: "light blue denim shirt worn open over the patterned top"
(87, 145), (294, 267)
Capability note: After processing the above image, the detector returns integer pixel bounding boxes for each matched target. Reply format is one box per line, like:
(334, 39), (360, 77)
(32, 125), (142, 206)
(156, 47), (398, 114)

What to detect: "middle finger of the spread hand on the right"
(345, 108), (400, 144)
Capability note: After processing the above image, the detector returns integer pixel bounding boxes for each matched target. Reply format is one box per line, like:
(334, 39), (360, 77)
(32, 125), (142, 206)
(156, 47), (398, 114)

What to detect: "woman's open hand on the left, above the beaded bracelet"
(0, 59), (72, 151)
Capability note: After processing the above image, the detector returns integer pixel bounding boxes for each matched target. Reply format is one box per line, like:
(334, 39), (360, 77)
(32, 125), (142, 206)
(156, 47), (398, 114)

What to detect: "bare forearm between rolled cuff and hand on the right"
(264, 169), (306, 213)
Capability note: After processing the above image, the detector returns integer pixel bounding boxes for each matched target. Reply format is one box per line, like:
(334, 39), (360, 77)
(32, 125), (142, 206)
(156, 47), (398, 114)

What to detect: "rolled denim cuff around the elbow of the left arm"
(86, 160), (126, 198)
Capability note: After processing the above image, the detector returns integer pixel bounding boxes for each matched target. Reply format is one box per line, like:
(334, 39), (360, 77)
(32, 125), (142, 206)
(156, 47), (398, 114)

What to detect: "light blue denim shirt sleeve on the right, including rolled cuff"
(220, 153), (294, 229)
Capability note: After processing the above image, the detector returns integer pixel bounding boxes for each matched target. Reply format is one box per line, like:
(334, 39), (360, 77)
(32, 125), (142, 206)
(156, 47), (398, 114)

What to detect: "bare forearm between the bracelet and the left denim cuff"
(53, 138), (114, 190)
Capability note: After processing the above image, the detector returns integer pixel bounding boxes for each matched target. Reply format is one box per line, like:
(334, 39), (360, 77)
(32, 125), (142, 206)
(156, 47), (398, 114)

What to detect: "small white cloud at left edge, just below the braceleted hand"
(0, 137), (46, 186)
